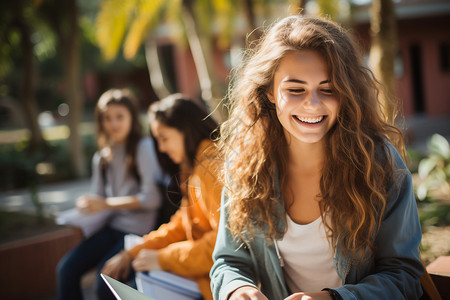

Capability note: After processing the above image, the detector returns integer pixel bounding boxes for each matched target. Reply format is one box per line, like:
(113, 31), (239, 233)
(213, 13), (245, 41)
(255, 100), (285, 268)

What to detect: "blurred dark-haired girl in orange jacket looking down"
(102, 94), (222, 299)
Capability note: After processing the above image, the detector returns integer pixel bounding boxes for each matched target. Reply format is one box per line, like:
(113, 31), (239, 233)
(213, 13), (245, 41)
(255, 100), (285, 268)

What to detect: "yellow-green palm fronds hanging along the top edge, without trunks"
(96, 0), (241, 60)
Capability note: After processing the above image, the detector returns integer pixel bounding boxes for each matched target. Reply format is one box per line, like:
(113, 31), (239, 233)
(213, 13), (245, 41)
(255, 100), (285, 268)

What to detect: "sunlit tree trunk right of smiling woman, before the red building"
(369, 0), (397, 124)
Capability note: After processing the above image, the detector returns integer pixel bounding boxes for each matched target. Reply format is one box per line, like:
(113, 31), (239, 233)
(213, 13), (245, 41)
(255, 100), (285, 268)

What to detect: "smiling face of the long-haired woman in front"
(267, 50), (339, 143)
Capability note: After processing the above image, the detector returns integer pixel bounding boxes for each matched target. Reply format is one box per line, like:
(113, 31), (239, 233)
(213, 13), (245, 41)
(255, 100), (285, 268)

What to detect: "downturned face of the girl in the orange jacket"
(150, 121), (186, 164)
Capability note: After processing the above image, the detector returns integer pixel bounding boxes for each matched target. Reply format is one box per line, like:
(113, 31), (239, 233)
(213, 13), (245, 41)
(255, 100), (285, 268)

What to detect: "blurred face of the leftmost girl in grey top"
(102, 104), (132, 144)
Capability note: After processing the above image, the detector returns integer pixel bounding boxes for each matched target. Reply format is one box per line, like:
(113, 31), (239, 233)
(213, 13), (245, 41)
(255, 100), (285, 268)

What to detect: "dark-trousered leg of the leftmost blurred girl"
(57, 227), (125, 300)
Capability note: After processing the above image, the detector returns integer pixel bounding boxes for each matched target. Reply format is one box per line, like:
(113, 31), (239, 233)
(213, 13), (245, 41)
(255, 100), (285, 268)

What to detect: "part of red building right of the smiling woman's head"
(354, 0), (450, 117)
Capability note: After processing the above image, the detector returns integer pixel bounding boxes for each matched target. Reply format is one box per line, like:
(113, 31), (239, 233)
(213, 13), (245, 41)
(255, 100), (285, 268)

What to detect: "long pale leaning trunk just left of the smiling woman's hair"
(182, 0), (226, 123)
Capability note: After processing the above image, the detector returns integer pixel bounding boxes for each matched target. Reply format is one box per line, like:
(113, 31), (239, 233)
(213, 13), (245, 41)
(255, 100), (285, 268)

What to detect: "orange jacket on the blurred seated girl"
(129, 141), (222, 300)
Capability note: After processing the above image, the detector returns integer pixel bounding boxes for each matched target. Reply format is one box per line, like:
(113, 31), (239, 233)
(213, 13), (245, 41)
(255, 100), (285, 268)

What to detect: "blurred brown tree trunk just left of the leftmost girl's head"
(65, 0), (87, 177)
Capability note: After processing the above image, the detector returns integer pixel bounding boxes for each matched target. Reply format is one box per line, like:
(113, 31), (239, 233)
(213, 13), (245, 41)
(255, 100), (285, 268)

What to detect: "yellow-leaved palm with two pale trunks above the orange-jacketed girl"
(97, 0), (239, 120)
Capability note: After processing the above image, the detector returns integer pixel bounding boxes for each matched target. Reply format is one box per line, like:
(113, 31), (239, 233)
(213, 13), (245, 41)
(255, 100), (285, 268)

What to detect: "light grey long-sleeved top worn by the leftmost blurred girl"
(91, 137), (164, 235)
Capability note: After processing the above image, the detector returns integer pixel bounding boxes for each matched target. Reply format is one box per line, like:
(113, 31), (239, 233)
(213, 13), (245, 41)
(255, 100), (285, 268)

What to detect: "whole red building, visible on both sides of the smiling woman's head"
(153, 0), (450, 117)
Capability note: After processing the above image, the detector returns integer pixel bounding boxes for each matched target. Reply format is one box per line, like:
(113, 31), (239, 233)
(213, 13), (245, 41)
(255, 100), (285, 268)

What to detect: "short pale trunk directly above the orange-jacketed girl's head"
(145, 35), (171, 99)
